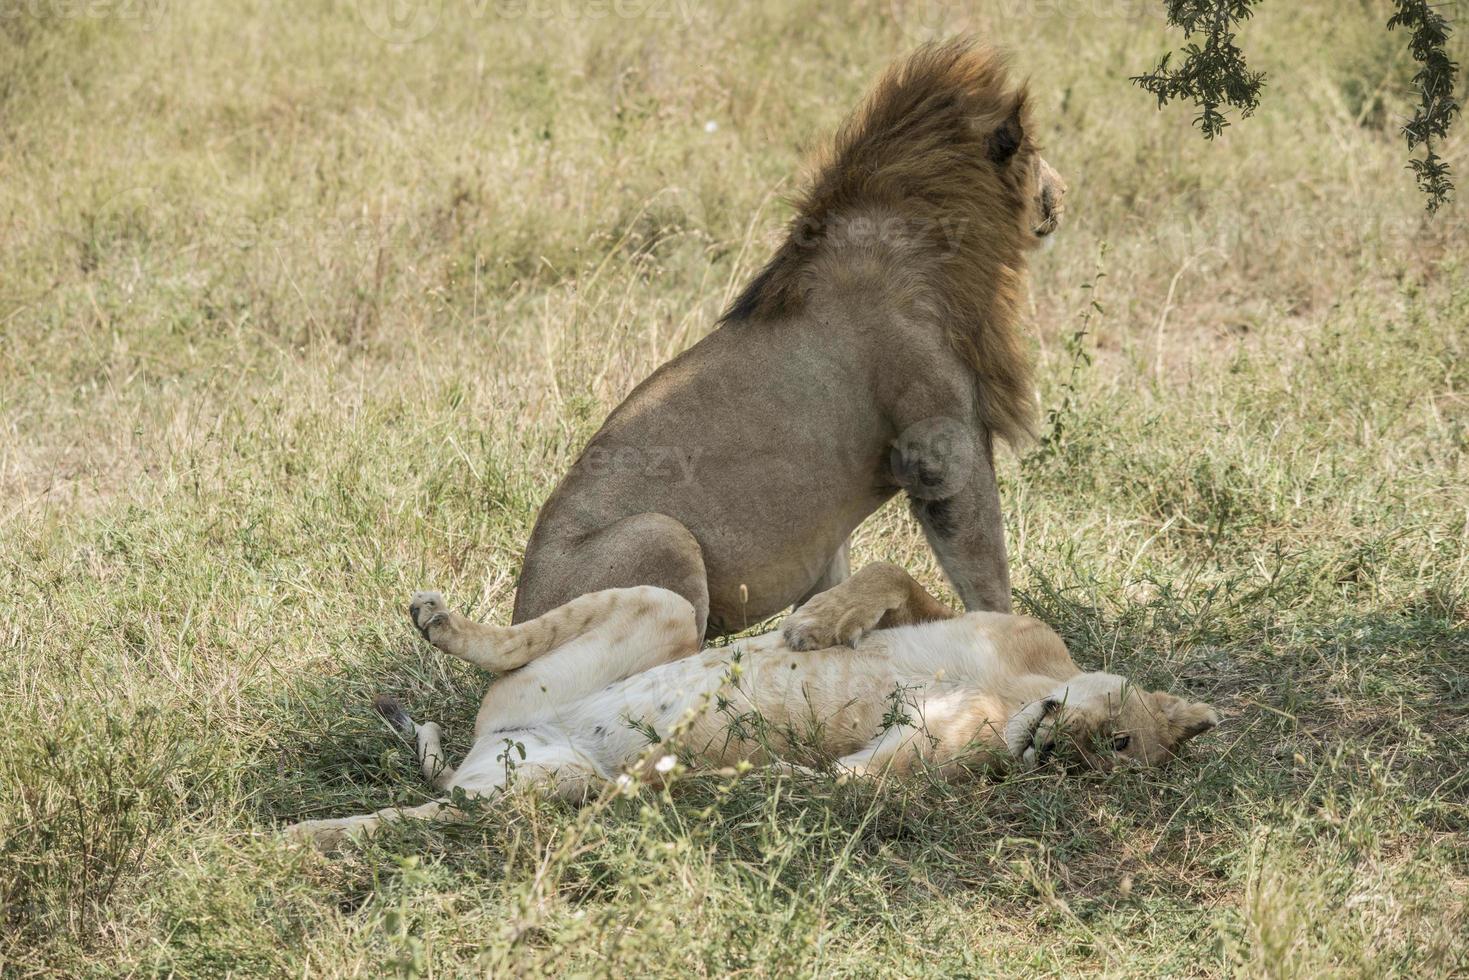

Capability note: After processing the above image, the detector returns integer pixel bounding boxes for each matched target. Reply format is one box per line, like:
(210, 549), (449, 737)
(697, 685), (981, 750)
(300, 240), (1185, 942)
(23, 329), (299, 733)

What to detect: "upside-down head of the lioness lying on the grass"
(1005, 673), (1219, 771)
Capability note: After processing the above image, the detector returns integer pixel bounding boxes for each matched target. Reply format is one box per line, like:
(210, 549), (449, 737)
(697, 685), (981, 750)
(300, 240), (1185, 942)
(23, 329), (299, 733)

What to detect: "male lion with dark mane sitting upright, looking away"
(513, 41), (1065, 655)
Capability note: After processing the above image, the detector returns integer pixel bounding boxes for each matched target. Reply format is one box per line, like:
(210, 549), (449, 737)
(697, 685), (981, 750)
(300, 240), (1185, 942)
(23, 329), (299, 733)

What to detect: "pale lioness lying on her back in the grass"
(291, 564), (1219, 846)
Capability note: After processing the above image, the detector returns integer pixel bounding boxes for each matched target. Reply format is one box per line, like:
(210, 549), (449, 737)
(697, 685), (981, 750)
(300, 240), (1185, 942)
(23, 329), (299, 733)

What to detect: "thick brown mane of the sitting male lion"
(721, 40), (1036, 442)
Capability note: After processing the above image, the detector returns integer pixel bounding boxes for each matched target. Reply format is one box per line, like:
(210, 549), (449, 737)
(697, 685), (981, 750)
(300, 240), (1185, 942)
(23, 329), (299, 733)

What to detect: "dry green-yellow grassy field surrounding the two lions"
(0, 0), (1469, 977)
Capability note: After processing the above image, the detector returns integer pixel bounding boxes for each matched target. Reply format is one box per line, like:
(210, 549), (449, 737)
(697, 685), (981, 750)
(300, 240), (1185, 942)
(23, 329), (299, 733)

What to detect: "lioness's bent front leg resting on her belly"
(782, 561), (958, 649)
